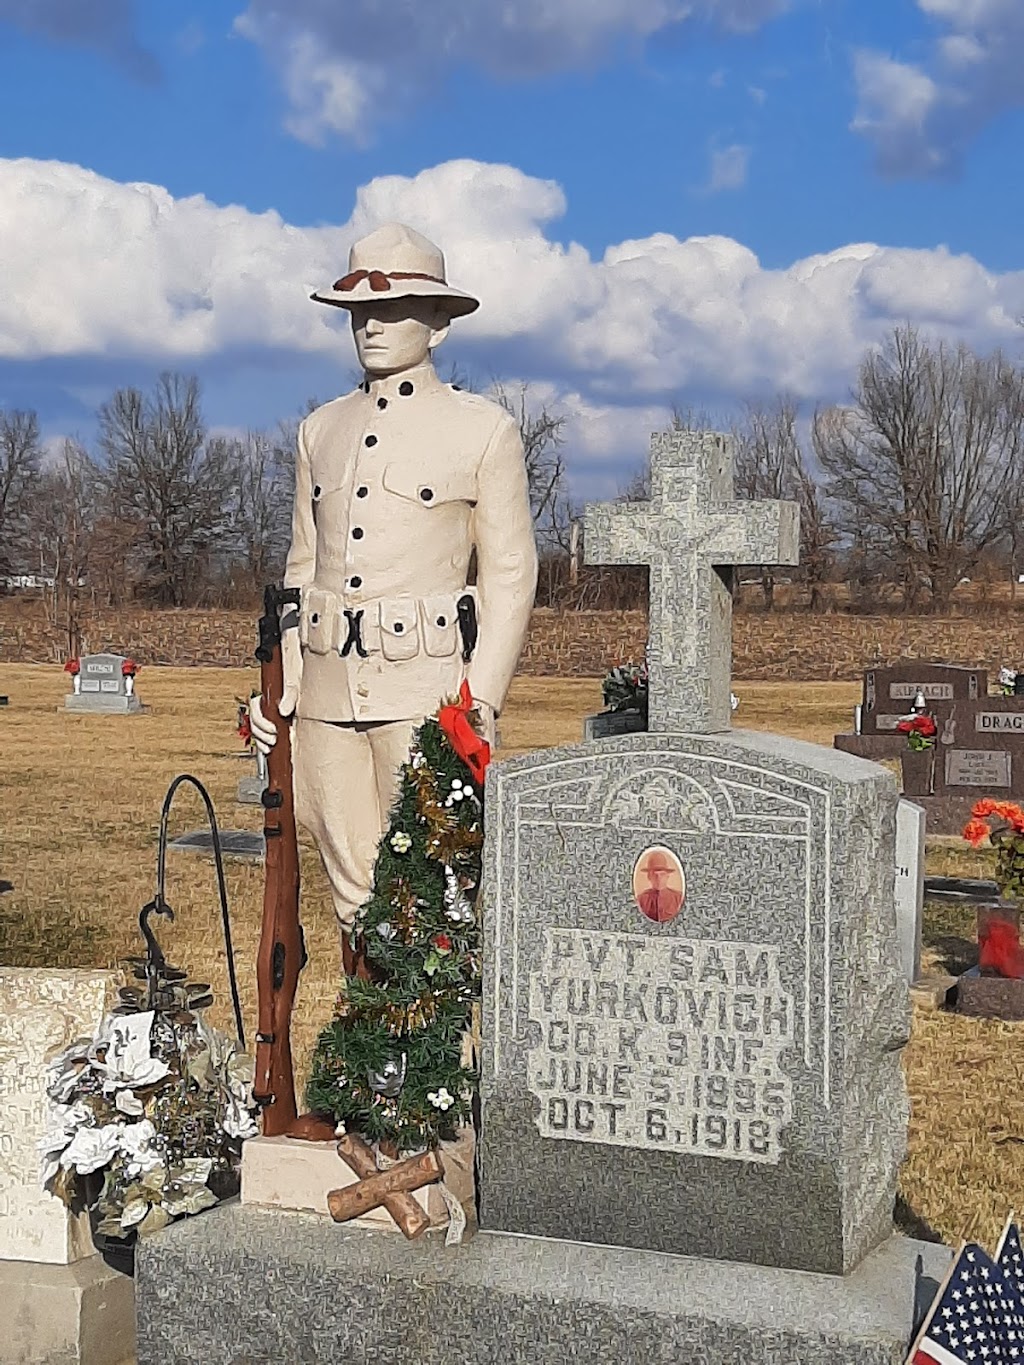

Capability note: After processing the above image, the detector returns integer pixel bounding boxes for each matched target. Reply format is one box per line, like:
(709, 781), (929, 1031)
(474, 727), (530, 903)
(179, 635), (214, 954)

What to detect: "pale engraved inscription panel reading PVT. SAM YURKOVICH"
(527, 928), (795, 1164)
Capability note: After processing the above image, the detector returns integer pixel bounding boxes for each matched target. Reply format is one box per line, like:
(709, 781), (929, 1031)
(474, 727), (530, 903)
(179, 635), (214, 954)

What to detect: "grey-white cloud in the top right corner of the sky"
(852, 0), (1024, 176)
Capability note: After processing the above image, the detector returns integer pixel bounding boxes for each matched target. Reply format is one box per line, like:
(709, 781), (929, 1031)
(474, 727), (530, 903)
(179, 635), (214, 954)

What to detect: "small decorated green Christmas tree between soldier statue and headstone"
(306, 718), (483, 1152)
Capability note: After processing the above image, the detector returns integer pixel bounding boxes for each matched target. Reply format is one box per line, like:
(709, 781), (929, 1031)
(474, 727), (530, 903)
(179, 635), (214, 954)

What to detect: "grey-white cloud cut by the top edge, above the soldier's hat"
(234, 0), (792, 145)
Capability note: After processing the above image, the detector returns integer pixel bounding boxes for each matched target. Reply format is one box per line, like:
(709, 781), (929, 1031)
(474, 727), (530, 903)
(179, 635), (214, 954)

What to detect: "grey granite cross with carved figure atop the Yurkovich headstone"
(584, 431), (800, 734)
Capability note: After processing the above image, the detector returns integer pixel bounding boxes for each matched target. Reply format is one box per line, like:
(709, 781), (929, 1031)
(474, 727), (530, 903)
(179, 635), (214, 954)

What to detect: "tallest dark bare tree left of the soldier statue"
(100, 374), (233, 606)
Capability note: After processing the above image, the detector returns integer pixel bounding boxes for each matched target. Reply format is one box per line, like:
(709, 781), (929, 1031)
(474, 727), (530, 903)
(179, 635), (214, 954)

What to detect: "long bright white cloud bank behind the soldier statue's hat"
(0, 160), (1024, 485)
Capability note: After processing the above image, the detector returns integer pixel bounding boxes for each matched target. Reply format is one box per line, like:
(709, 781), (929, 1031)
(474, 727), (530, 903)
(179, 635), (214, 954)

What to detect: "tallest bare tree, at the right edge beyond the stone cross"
(815, 326), (1024, 612)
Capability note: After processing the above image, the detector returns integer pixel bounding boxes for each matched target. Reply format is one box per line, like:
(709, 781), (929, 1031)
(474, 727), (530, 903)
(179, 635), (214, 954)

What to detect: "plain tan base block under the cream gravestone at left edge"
(0, 1256), (135, 1365)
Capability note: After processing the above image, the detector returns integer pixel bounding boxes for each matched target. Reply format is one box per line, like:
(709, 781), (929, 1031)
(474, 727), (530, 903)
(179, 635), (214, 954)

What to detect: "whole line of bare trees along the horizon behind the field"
(0, 326), (1024, 635)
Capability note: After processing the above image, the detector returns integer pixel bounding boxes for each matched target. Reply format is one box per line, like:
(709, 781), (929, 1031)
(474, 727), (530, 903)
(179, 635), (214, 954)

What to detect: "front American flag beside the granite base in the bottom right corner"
(908, 1237), (1024, 1365)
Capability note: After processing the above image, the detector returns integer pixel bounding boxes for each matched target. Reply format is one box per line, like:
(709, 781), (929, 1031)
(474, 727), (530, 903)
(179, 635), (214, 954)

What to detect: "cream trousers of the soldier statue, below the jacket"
(294, 719), (416, 935)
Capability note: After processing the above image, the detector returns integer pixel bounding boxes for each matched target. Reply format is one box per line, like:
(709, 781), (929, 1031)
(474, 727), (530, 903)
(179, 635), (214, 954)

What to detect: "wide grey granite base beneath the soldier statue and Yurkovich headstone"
(137, 1204), (950, 1365)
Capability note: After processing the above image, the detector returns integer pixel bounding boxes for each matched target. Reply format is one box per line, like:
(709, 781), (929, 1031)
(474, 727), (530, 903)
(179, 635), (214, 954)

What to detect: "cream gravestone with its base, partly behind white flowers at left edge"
(0, 968), (134, 1365)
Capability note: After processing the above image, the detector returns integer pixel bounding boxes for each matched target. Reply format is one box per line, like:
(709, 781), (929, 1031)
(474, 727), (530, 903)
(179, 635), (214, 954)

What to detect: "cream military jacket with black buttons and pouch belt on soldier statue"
(285, 363), (537, 722)
